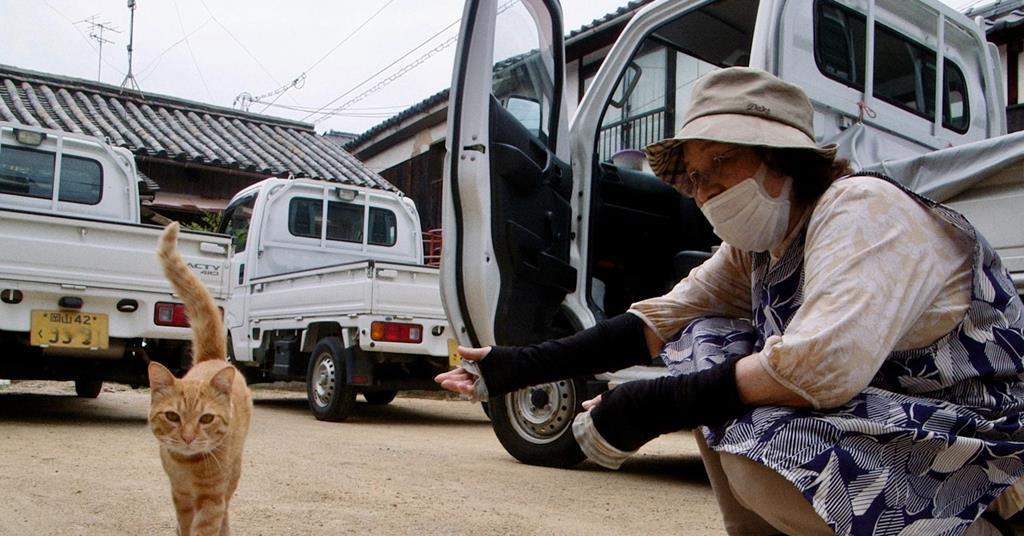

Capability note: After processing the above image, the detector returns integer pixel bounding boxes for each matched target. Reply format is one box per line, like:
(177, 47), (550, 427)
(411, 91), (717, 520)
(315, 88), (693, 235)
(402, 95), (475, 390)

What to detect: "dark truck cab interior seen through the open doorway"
(589, 0), (758, 316)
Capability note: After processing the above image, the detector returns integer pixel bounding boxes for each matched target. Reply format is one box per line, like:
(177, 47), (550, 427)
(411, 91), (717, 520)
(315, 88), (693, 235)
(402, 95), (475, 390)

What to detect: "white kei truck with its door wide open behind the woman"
(441, 0), (1024, 466)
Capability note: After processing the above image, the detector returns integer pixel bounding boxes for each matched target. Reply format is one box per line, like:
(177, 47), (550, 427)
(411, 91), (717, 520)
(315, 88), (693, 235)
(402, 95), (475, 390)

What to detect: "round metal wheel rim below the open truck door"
(506, 380), (577, 444)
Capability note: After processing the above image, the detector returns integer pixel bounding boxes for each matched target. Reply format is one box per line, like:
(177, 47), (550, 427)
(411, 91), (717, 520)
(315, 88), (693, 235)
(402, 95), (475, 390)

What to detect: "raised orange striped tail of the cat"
(157, 221), (227, 363)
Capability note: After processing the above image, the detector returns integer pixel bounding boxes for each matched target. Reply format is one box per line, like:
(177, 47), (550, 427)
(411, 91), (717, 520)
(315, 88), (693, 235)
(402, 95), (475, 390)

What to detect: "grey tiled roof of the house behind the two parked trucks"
(0, 66), (396, 191)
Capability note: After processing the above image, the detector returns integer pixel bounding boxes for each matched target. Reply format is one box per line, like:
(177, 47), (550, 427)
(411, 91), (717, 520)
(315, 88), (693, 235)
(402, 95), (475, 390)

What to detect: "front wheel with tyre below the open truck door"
(487, 379), (586, 467)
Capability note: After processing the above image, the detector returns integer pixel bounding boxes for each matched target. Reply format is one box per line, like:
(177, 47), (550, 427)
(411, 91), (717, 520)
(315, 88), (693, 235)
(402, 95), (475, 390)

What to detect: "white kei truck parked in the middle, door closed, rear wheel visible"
(220, 178), (452, 421)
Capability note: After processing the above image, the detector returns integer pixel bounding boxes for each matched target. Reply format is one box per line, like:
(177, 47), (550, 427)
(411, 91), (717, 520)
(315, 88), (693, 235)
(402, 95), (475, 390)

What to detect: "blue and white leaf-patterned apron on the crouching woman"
(663, 176), (1024, 535)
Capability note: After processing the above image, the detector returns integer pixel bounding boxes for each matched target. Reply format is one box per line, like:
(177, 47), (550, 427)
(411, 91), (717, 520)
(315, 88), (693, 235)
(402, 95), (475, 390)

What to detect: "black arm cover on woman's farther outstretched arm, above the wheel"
(477, 313), (651, 397)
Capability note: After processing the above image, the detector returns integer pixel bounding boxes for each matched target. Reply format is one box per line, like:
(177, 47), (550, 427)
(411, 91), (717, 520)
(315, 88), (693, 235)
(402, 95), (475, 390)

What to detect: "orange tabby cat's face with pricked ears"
(150, 363), (234, 456)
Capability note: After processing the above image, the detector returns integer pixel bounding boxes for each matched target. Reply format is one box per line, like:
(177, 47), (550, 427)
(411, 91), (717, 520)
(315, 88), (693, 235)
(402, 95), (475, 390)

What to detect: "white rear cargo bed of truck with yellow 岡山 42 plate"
(0, 209), (230, 339)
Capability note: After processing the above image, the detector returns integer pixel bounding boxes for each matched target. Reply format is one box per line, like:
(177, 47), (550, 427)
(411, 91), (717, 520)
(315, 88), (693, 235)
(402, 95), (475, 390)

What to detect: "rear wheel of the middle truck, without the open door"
(306, 337), (355, 422)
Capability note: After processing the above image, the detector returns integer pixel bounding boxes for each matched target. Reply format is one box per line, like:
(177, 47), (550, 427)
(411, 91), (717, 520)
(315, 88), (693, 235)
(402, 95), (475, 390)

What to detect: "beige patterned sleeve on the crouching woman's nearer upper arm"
(760, 177), (972, 408)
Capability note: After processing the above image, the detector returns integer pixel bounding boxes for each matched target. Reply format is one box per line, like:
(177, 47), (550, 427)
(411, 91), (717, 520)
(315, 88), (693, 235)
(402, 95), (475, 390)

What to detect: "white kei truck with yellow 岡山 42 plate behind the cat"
(0, 123), (230, 398)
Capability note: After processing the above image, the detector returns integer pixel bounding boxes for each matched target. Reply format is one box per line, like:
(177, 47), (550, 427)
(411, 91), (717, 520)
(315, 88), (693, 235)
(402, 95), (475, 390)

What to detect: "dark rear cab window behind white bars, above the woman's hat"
(814, 0), (971, 133)
